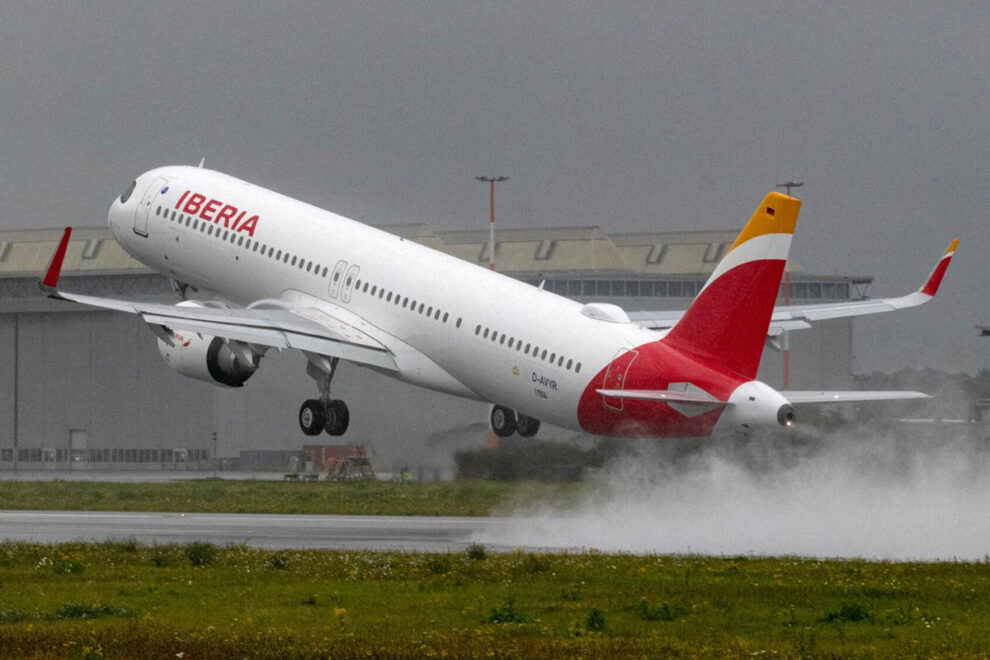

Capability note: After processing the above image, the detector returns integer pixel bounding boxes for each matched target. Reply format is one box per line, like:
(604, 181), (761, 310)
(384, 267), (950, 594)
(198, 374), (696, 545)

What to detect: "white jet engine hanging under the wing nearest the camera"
(156, 301), (262, 387)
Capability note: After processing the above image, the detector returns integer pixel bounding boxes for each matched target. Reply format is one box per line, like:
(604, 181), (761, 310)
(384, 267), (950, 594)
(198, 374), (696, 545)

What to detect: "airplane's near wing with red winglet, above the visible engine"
(40, 227), (398, 371)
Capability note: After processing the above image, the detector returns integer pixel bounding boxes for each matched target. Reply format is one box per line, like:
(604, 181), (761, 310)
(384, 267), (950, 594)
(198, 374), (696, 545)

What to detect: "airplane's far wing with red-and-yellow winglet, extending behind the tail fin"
(629, 239), (959, 337)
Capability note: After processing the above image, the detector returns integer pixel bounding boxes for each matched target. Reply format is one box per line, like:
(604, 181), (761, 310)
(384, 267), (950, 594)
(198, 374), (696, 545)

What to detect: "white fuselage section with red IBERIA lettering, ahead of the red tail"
(109, 167), (658, 429)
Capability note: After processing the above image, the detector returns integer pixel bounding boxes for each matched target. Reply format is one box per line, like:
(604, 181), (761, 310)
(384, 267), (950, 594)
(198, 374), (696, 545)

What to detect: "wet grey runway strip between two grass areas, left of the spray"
(0, 511), (510, 552)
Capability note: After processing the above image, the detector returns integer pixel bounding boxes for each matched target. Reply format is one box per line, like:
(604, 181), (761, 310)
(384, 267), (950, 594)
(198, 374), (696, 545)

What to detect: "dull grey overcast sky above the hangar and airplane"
(0, 0), (990, 371)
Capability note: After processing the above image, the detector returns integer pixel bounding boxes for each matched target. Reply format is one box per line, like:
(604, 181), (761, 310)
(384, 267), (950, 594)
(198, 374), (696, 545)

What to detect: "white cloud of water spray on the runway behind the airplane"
(478, 426), (990, 560)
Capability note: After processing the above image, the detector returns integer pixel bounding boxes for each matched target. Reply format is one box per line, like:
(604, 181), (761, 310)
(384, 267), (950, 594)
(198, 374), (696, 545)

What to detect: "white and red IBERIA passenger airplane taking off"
(39, 163), (958, 438)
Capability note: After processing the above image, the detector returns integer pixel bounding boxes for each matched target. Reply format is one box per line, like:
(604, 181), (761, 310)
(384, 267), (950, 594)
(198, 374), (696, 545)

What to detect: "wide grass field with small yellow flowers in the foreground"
(0, 543), (990, 658)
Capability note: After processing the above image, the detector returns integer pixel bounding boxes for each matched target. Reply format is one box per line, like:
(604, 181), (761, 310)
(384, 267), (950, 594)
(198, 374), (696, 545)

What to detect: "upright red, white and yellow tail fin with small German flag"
(661, 192), (801, 378)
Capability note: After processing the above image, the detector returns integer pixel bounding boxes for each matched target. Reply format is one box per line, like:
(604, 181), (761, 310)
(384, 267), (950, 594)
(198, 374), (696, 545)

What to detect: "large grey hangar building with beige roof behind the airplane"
(0, 224), (871, 470)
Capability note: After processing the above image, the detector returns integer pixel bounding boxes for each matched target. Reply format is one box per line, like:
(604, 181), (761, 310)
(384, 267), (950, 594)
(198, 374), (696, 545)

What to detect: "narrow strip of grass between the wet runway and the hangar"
(0, 479), (578, 516)
